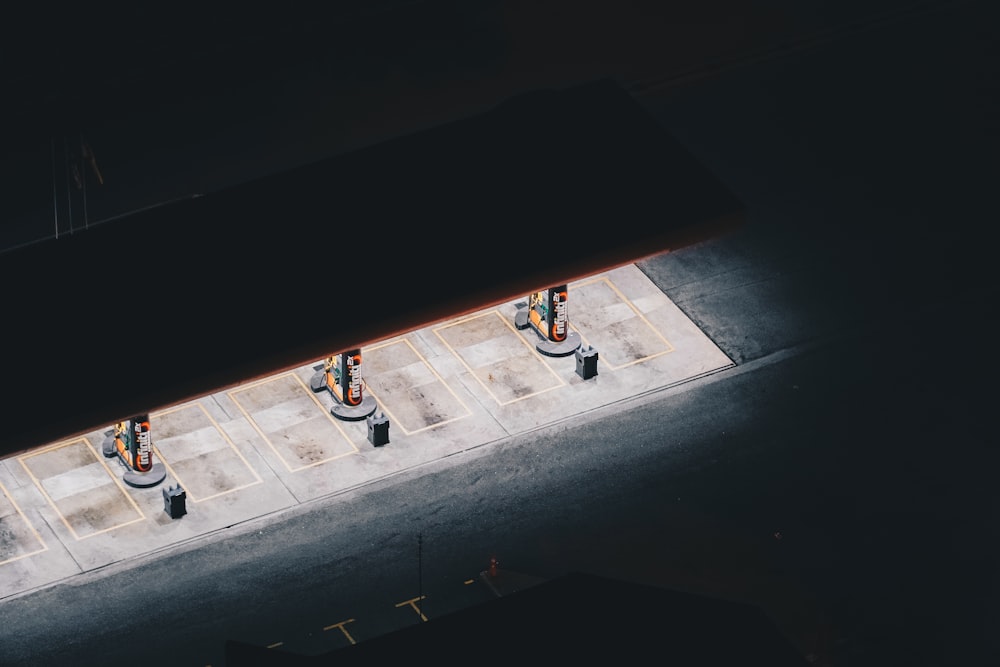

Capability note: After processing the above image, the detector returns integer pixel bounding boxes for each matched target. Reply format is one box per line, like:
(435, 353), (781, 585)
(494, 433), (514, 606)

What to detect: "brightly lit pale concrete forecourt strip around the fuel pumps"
(0, 264), (734, 598)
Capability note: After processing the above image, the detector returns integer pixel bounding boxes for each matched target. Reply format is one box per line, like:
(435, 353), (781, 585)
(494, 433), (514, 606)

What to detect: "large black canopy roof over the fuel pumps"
(0, 75), (743, 454)
